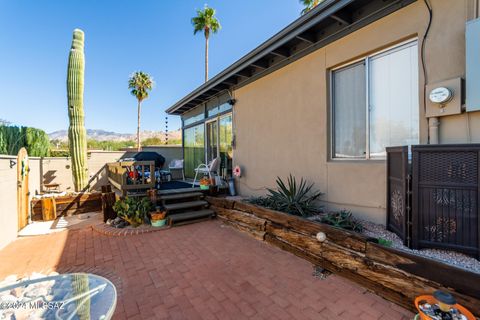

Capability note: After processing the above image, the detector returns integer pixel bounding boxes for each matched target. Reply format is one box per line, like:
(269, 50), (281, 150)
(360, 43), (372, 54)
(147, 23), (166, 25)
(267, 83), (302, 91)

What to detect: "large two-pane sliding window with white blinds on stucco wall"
(332, 41), (419, 159)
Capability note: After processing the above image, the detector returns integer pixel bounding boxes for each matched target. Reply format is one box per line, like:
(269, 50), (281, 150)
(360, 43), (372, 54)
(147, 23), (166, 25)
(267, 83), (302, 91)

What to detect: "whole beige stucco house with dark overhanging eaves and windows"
(168, 0), (480, 223)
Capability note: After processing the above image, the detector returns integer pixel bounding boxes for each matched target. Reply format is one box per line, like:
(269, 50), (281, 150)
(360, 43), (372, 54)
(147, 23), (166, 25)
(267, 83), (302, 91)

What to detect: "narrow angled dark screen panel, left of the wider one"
(386, 146), (411, 246)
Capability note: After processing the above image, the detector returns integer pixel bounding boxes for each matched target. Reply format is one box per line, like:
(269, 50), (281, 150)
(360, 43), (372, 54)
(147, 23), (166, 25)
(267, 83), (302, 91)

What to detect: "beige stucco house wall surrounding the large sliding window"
(234, 0), (480, 223)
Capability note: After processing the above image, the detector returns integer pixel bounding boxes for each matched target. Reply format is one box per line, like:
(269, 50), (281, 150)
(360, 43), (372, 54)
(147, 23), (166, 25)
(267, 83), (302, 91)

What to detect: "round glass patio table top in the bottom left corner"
(0, 273), (117, 320)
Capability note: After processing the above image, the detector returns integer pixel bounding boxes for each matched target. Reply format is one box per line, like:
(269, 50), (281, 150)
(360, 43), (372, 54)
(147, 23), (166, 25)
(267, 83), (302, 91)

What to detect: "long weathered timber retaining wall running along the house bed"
(206, 197), (480, 315)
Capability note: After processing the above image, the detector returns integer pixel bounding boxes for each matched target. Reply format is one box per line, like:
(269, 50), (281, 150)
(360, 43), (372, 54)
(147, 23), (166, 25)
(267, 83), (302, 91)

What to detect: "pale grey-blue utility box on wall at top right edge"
(465, 19), (480, 112)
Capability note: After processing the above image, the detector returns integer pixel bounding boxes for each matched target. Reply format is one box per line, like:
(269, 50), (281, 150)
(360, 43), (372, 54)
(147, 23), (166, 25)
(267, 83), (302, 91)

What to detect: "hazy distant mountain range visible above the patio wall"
(48, 129), (182, 141)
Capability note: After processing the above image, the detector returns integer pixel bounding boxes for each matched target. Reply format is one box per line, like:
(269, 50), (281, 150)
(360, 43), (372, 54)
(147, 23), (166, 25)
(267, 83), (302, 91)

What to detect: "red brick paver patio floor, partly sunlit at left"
(0, 221), (412, 319)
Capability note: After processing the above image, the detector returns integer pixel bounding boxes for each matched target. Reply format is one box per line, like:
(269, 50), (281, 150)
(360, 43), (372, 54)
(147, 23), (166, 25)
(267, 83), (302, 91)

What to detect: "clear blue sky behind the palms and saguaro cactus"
(0, 0), (302, 133)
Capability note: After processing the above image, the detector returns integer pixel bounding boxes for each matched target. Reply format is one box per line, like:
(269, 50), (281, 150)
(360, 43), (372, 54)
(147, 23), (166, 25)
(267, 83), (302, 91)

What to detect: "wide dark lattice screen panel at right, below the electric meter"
(412, 144), (480, 257)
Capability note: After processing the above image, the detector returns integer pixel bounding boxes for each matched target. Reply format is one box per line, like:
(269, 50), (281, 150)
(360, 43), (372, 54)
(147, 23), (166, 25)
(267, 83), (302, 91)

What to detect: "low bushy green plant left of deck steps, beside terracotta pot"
(113, 197), (153, 227)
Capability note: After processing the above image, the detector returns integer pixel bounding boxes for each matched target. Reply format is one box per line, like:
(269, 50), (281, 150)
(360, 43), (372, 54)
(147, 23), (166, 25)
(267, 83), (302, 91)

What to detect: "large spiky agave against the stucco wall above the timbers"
(267, 175), (322, 217)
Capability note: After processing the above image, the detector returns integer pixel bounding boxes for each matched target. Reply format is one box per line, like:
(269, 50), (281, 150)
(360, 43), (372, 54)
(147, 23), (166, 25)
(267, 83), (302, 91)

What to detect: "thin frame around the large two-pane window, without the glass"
(328, 38), (420, 161)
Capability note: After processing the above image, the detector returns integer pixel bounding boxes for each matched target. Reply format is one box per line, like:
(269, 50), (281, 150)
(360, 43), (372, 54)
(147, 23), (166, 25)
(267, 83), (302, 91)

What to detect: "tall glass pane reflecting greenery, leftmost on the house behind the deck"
(183, 123), (205, 178)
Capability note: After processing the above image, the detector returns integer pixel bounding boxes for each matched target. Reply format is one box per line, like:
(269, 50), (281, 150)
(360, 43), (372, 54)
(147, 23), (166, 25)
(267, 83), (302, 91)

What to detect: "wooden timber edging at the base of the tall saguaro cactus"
(31, 193), (102, 220)
